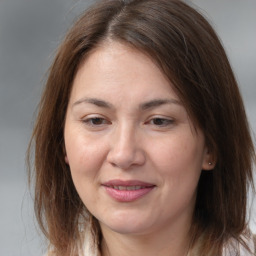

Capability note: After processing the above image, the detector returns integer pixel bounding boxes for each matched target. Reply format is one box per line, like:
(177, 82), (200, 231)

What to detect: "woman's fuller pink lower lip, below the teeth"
(105, 187), (154, 202)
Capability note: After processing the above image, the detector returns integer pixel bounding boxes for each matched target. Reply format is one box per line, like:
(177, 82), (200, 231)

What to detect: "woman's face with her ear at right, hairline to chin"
(64, 42), (214, 234)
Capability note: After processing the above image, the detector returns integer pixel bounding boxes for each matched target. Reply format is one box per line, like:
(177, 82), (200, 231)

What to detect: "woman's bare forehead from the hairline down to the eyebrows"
(69, 42), (198, 133)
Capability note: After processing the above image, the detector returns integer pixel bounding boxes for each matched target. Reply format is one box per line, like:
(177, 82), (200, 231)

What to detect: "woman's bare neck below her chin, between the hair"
(101, 222), (190, 256)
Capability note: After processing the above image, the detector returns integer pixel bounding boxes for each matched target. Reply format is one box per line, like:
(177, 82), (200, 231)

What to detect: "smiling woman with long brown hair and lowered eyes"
(27, 0), (255, 256)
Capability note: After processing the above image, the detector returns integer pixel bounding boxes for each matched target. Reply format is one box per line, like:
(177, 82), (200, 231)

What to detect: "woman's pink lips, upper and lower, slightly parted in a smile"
(102, 180), (155, 202)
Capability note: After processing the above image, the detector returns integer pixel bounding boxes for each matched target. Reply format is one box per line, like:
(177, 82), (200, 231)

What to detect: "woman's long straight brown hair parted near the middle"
(28, 0), (255, 255)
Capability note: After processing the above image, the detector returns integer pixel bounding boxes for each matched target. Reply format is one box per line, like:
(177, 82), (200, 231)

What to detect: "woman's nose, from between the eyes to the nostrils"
(107, 126), (146, 170)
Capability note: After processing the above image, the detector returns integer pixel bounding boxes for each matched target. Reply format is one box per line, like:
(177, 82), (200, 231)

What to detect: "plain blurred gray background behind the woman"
(0, 0), (256, 256)
